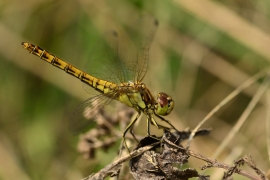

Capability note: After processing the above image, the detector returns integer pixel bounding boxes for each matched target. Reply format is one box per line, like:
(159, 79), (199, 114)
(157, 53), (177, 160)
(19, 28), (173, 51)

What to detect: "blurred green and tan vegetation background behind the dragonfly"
(0, 0), (270, 180)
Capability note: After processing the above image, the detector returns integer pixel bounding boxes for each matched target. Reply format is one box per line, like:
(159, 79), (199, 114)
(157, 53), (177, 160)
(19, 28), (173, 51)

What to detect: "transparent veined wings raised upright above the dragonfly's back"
(83, 16), (158, 94)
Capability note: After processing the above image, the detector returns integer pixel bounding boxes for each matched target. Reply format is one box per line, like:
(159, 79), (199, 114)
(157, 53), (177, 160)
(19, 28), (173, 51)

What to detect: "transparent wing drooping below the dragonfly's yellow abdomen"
(69, 94), (113, 134)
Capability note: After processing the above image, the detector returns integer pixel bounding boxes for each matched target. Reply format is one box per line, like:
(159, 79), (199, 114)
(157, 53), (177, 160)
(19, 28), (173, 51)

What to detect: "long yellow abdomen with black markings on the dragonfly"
(22, 42), (118, 94)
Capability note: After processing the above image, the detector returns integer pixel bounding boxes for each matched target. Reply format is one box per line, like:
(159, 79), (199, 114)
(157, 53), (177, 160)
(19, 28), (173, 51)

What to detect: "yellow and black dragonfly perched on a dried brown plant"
(22, 18), (177, 150)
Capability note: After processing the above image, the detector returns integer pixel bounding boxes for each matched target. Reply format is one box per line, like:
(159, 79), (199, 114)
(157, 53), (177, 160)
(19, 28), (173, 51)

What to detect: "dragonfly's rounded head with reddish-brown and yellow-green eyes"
(155, 92), (174, 116)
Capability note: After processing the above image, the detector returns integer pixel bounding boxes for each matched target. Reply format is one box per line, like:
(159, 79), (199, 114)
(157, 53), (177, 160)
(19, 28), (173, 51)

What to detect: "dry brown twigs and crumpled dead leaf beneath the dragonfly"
(83, 131), (267, 180)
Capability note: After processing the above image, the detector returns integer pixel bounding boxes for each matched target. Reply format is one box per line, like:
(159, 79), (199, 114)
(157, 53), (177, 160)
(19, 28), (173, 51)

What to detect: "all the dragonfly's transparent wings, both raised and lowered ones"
(73, 15), (158, 134)
